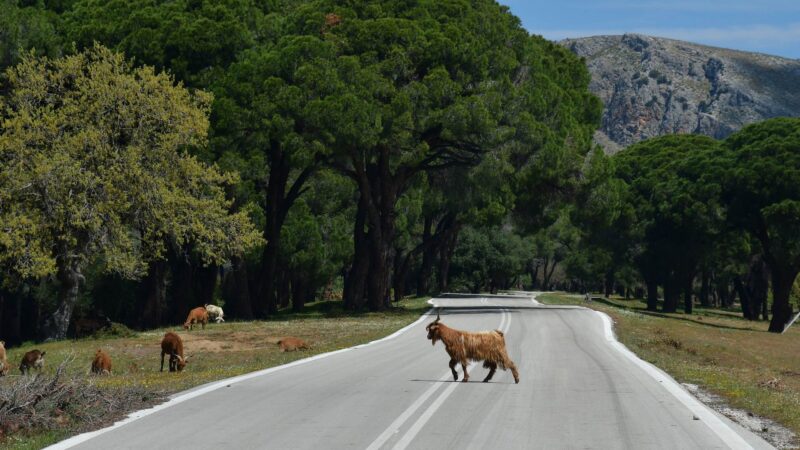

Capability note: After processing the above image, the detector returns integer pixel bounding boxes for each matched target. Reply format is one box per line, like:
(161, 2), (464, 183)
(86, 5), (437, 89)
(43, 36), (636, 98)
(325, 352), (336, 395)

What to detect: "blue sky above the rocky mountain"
(499, 0), (800, 58)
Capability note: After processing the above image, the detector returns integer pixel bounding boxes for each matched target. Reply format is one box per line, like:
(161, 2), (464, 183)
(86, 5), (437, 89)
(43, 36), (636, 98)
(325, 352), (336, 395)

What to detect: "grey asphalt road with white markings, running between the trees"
(53, 298), (770, 450)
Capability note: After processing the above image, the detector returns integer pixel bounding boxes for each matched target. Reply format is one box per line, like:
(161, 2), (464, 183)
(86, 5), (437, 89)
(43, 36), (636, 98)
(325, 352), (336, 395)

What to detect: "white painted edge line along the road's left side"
(45, 306), (433, 450)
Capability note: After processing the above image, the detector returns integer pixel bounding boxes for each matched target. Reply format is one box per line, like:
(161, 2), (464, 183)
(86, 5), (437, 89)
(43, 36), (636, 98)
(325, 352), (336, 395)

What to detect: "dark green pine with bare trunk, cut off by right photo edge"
(723, 118), (800, 333)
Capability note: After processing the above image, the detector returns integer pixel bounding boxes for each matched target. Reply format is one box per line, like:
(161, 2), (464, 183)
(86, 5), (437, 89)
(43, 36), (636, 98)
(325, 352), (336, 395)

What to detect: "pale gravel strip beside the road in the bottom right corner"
(682, 383), (798, 449)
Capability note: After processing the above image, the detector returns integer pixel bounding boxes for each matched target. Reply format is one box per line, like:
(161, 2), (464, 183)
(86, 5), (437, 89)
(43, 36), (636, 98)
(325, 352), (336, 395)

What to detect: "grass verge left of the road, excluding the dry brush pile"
(0, 297), (429, 449)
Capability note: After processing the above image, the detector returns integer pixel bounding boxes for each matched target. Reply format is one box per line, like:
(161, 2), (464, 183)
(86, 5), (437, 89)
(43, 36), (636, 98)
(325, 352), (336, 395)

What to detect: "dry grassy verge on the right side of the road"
(537, 293), (800, 445)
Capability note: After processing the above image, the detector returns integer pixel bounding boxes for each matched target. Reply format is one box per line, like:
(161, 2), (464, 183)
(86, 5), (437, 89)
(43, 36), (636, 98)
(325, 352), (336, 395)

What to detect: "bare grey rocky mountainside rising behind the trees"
(561, 34), (800, 153)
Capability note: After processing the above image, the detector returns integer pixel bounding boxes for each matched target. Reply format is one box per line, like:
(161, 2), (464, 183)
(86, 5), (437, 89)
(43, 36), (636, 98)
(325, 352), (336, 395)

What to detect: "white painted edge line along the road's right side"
(584, 308), (753, 450)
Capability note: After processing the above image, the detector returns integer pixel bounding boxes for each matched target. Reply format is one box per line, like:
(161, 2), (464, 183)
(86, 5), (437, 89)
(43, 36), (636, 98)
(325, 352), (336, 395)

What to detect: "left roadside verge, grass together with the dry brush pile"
(0, 297), (429, 449)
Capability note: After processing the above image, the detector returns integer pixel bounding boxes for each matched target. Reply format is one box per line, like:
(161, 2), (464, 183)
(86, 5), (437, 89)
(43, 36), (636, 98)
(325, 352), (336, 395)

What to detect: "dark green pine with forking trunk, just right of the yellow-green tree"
(213, 31), (335, 315)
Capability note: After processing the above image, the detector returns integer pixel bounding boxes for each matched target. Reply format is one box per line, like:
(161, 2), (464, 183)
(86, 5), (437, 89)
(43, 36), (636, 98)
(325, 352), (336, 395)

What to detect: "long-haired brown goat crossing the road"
(425, 314), (519, 383)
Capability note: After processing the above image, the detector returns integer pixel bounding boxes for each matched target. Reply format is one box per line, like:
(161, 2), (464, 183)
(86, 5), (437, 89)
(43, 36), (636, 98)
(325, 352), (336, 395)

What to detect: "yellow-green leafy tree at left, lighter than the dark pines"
(0, 46), (259, 338)
